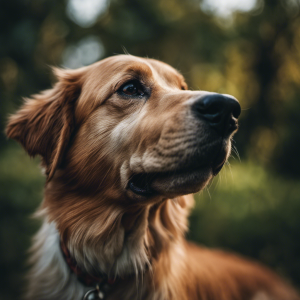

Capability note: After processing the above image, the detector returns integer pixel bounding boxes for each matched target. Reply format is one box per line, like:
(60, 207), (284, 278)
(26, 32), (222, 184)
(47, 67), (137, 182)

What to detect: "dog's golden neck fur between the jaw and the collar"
(43, 178), (192, 278)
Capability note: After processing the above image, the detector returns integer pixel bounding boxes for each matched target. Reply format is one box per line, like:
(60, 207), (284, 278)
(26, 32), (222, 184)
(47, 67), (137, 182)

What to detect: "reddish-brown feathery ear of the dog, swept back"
(6, 69), (83, 181)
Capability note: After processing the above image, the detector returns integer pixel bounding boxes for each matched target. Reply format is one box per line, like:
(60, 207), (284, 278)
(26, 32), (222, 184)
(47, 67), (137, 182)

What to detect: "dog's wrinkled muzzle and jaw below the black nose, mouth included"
(120, 111), (234, 200)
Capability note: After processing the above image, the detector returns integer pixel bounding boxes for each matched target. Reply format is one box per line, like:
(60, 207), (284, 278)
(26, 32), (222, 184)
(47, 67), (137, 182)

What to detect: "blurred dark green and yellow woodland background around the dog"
(0, 0), (300, 300)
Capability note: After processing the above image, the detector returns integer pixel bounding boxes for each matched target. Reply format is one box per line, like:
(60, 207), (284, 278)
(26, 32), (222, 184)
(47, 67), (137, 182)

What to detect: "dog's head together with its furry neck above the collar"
(7, 55), (240, 275)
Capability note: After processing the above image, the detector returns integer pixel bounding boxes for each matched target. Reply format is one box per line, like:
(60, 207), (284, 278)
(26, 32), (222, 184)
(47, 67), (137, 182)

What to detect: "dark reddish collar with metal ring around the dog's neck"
(60, 240), (116, 300)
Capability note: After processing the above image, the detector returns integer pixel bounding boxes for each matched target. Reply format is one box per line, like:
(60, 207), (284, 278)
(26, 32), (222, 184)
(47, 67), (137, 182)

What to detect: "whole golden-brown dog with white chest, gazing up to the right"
(7, 55), (299, 300)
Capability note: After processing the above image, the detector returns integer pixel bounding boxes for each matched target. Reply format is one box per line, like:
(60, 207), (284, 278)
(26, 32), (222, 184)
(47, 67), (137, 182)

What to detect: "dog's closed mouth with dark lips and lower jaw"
(127, 149), (228, 197)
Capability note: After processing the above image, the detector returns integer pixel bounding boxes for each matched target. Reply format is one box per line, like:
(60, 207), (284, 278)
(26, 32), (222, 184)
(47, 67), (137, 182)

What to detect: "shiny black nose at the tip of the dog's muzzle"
(192, 94), (241, 136)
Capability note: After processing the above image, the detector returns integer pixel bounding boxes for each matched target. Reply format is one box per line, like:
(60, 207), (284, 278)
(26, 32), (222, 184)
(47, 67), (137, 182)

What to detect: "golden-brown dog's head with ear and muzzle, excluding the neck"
(7, 55), (240, 200)
